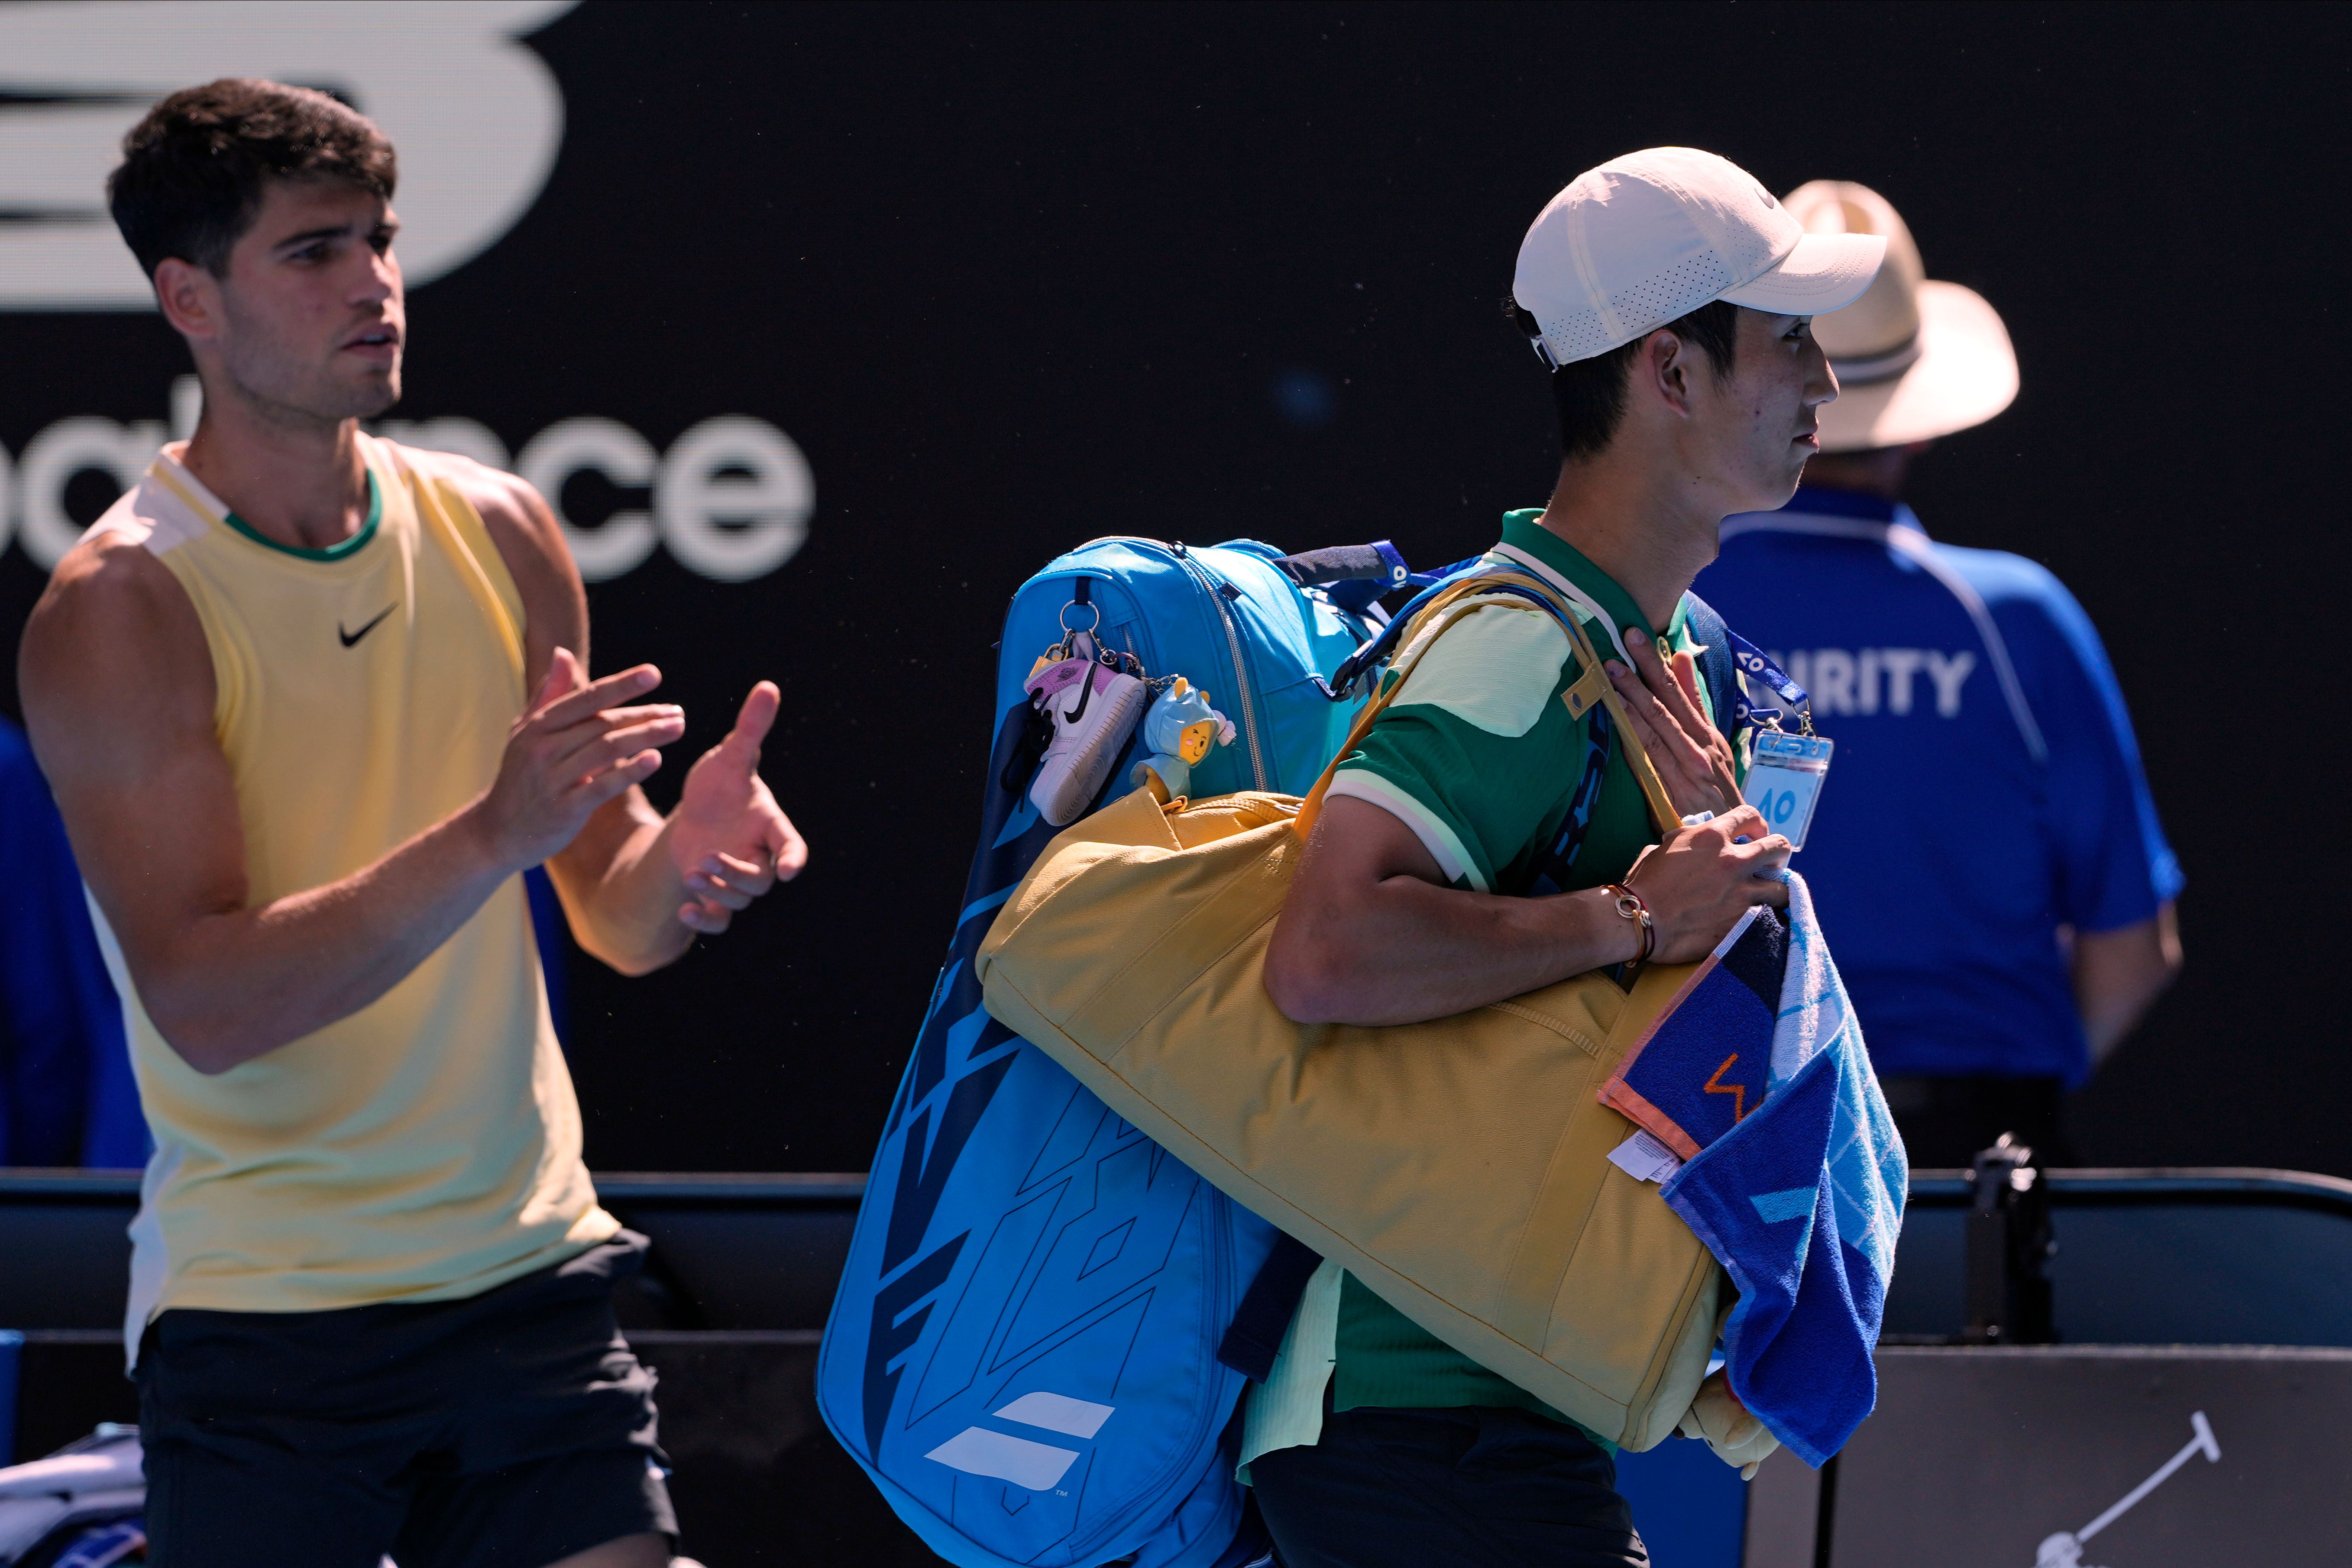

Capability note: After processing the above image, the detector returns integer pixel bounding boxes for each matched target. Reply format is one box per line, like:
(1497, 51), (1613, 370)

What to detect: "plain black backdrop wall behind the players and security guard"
(0, 0), (2352, 1173)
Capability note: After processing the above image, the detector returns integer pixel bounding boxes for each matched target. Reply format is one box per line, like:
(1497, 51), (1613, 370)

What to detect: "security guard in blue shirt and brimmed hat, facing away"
(1698, 181), (2183, 1166)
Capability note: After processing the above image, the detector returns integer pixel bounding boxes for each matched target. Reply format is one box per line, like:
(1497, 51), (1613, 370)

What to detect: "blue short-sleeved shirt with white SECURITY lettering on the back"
(1696, 489), (2183, 1086)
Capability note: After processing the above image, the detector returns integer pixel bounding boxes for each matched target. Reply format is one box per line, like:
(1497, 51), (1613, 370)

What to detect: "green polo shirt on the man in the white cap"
(1331, 510), (1705, 1425)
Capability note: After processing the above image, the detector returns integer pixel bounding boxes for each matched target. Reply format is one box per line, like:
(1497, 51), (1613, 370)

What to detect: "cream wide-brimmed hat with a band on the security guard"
(1783, 179), (2018, 451)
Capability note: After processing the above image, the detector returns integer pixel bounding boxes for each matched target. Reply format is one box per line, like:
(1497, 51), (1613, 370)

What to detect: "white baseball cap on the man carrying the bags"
(1510, 148), (1886, 364)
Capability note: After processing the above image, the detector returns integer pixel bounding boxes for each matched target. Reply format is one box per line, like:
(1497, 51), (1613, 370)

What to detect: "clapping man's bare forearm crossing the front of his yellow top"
(129, 806), (515, 1074)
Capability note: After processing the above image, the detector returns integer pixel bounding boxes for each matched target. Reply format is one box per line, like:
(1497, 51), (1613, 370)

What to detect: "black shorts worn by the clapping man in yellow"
(139, 1232), (677, 1568)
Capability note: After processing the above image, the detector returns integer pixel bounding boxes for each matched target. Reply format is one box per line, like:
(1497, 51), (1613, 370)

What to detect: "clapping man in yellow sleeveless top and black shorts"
(19, 80), (807, 1568)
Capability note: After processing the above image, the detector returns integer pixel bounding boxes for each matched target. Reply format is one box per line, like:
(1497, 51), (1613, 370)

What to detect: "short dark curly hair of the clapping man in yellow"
(106, 75), (400, 278)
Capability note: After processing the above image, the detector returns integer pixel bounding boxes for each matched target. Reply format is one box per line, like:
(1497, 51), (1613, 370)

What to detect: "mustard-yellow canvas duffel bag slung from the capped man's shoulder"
(976, 576), (1721, 1451)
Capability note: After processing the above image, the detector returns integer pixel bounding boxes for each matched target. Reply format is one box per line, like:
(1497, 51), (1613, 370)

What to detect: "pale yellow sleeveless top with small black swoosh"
(97, 435), (618, 1356)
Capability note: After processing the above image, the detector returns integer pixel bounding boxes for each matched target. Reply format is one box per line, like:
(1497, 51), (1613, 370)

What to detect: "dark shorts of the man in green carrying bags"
(1249, 1406), (1649, 1568)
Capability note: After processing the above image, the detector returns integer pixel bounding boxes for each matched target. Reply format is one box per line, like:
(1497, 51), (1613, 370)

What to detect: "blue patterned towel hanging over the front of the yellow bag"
(1602, 872), (1910, 1467)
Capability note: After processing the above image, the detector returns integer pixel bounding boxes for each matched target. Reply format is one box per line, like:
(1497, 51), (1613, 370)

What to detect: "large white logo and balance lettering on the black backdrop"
(0, 0), (816, 583)
